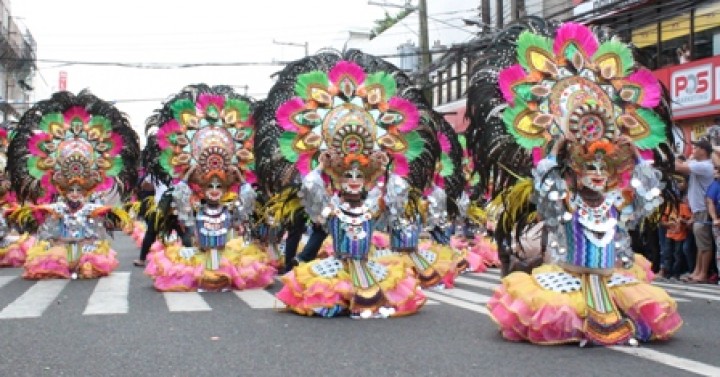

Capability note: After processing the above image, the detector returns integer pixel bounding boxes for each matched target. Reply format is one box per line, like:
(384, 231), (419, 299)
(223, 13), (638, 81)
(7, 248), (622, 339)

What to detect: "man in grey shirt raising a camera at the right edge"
(675, 139), (714, 283)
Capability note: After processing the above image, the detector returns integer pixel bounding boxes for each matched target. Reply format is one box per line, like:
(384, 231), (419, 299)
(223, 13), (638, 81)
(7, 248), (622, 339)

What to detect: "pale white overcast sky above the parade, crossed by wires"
(10, 0), (400, 138)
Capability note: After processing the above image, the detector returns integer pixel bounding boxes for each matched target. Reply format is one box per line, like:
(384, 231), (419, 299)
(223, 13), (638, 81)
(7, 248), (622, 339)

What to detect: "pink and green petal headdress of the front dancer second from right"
(276, 60), (423, 182)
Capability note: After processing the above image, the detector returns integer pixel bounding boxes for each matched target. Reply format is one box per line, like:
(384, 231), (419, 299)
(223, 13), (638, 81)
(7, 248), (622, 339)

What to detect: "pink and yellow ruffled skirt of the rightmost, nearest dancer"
(488, 255), (683, 345)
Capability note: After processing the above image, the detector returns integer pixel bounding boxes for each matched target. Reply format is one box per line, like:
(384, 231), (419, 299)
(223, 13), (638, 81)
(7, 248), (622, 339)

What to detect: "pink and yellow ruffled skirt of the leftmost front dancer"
(23, 240), (119, 280)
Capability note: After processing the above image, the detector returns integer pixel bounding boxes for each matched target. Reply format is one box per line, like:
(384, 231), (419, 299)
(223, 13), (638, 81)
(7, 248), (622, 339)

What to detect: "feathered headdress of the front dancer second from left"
(147, 84), (255, 195)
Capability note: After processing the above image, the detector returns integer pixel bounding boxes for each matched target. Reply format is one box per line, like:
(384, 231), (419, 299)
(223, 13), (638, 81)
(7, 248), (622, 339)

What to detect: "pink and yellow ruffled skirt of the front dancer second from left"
(145, 238), (277, 292)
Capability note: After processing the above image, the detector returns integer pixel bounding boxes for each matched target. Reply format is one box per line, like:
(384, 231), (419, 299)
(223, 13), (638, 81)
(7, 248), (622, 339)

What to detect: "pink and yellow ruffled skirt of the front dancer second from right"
(276, 256), (426, 318)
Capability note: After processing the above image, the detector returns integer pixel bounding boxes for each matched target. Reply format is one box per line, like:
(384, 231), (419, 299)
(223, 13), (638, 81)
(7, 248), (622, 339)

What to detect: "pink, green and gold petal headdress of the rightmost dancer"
(498, 23), (666, 184)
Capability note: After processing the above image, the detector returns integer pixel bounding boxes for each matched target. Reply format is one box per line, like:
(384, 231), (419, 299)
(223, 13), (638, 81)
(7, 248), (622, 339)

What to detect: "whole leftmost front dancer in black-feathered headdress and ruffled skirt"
(8, 91), (139, 279)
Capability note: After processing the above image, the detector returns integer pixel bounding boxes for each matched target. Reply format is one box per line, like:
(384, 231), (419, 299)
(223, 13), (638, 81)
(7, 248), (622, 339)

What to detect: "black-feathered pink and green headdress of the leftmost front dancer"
(9, 91), (139, 202)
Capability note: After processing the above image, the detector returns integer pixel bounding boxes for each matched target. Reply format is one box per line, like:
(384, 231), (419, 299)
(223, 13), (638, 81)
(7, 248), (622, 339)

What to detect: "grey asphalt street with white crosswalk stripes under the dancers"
(0, 234), (720, 377)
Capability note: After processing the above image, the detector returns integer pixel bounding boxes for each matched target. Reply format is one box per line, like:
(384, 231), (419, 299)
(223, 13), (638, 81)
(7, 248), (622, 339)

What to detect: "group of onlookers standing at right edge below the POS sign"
(638, 134), (720, 284)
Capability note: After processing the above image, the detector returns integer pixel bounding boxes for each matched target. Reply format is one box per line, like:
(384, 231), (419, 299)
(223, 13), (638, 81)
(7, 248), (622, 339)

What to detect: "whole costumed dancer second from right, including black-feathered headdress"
(256, 50), (450, 318)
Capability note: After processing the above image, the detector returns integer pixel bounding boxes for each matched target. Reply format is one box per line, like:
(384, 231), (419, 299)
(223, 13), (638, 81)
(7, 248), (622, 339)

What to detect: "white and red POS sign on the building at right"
(670, 64), (714, 109)
